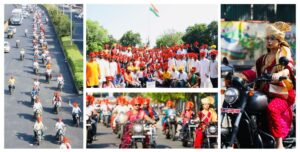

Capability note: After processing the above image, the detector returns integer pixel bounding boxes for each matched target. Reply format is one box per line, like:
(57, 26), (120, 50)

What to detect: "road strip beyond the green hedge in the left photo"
(57, 5), (83, 55)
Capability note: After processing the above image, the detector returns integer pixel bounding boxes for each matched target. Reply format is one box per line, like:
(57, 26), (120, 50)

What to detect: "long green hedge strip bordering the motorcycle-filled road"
(43, 4), (83, 90)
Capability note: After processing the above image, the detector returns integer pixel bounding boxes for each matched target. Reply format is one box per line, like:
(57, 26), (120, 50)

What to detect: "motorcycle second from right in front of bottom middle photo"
(179, 119), (197, 147)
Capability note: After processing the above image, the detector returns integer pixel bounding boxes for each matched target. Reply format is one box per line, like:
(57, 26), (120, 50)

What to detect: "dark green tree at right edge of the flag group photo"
(182, 21), (218, 45)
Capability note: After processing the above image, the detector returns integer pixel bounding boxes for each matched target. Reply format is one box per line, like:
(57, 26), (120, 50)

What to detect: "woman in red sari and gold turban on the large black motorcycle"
(237, 22), (296, 148)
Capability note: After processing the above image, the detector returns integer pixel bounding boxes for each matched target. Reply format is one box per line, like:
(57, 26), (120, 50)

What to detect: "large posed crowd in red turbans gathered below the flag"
(86, 41), (218, 88)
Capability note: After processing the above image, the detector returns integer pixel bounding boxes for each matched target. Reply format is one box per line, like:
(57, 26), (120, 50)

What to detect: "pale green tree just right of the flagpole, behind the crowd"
(156, 31), (183, 47)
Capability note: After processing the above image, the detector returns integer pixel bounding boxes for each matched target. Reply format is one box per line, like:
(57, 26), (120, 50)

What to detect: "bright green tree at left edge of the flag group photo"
(86, 20), (110, 51)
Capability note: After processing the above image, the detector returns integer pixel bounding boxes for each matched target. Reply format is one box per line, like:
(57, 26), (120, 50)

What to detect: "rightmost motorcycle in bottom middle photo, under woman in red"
(201, 123), (218, 148)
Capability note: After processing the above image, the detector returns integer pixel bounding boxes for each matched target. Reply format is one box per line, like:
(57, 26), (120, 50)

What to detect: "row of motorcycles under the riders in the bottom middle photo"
(86, 104), (218, 148)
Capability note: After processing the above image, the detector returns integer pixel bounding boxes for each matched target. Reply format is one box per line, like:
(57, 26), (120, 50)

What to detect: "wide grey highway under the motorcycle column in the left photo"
(4, 5), (83, 148)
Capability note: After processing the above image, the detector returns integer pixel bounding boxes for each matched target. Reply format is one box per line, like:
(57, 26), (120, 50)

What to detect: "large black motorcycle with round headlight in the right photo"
(221, 57), (296, 148)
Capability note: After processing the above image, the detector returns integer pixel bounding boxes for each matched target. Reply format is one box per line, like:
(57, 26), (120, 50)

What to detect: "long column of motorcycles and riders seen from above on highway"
(9, 8), (80, 145)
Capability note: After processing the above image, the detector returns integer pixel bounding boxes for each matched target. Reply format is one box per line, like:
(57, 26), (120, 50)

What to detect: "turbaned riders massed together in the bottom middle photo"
(86, 94), (217, 148)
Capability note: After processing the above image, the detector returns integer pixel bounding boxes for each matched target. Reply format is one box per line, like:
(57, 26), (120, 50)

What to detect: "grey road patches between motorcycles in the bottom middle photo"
(87, 116), (193, 149)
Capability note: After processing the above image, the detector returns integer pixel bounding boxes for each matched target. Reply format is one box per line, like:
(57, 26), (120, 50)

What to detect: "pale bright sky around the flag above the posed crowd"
(86, 4), (218, 46)
